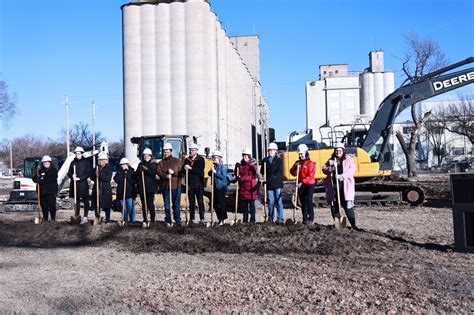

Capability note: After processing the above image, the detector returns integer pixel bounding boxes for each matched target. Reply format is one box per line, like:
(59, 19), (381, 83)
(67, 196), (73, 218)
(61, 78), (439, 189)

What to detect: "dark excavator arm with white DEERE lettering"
(362, 57), (474, 170)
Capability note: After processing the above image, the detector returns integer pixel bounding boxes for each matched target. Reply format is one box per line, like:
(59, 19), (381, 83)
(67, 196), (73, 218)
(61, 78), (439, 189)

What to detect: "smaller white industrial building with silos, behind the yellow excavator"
(306, 51), (395, 142)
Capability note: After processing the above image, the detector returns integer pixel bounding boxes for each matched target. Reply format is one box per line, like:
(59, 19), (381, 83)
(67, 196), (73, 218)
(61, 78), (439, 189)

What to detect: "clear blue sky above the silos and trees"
(0, 0), (474, 141)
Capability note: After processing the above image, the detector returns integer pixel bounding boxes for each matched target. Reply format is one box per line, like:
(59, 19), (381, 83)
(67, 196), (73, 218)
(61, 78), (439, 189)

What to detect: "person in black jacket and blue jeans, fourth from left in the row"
(114, 158), (136, 224)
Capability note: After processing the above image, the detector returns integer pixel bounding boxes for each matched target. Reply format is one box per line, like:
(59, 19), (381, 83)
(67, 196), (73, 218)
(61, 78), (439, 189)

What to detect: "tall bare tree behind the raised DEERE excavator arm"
(396, 32), (448, 177)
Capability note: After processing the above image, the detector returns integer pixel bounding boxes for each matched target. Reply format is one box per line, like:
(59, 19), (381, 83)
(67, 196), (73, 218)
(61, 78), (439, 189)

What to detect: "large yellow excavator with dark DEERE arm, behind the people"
(282, 57), (474, 205)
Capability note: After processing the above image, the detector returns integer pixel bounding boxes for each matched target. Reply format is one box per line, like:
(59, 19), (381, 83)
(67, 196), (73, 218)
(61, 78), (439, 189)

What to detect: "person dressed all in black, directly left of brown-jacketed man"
(134, 148), (158, 222)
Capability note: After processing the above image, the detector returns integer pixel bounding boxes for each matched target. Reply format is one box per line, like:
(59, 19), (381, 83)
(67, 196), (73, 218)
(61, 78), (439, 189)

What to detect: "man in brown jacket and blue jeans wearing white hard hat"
(156, 142), (182, 225)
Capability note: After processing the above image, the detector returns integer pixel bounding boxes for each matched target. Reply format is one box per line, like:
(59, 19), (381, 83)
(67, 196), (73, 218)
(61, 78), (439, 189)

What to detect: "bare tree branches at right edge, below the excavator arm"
(436, 94), (474, 144)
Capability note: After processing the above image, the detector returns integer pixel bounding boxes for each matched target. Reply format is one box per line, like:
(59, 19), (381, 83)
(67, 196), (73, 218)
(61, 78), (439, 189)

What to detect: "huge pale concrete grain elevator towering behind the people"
(122, 0), (268, 164)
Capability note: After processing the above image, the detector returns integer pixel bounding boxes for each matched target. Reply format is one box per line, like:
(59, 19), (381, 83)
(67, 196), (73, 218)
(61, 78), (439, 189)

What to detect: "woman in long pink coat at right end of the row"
(322, 143), (359, 230)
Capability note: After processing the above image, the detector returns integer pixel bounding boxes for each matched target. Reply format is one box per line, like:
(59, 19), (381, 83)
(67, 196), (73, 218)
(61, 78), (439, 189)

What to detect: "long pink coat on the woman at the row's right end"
(323, 154), (356, 202)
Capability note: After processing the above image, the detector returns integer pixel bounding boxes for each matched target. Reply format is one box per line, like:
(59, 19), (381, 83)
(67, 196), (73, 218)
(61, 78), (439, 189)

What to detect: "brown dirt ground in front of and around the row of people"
(0, 175), (474, 313)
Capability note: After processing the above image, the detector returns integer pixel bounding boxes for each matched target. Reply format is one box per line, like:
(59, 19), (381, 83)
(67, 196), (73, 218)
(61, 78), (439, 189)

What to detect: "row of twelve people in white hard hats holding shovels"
(33, 143), (357, 229)
